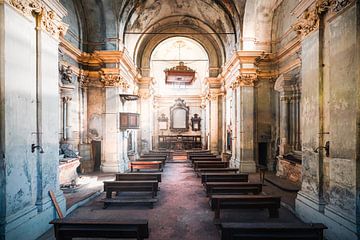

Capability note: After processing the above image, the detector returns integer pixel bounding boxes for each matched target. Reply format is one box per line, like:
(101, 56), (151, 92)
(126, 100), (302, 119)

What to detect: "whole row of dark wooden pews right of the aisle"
(188, 151), (326, 240)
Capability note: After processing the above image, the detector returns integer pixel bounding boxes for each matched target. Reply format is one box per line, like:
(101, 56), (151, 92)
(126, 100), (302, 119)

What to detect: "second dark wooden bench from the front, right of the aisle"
(210, 195), (281, 219)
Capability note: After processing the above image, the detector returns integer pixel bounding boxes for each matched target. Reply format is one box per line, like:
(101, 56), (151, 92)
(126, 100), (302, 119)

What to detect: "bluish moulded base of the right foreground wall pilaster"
(295, 191), (358, 240)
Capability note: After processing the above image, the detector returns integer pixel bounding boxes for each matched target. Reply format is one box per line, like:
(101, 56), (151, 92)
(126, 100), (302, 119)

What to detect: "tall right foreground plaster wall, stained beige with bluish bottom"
(296, 4), (359, 240)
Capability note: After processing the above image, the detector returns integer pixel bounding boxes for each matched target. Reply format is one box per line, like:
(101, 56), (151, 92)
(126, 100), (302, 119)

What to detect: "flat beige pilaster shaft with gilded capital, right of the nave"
(239, 82), (256, 172)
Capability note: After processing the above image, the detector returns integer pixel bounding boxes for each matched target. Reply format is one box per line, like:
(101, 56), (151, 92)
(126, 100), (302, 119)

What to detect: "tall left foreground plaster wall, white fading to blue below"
(0, 3), (65, 239)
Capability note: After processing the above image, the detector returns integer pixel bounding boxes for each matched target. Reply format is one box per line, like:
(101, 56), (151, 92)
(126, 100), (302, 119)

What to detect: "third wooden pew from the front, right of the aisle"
(205, 182), (262, 196)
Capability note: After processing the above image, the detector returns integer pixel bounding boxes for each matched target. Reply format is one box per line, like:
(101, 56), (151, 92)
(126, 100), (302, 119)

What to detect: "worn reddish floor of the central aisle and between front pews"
(39, 153), (301, 240)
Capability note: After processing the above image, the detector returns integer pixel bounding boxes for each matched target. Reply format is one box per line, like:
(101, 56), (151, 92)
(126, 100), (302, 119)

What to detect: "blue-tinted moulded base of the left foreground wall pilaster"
(0, 191), (66, 240)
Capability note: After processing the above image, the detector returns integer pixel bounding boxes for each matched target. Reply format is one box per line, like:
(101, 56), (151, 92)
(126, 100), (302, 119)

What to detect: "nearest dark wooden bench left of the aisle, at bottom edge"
(50, 218), (149, 240)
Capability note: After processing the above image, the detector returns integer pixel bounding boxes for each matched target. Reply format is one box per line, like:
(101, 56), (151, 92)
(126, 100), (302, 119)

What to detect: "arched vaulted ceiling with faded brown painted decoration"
(61, 0), (246, 63)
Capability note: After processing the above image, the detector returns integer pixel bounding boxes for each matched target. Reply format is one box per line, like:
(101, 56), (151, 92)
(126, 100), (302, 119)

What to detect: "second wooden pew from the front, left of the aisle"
(104, 180), (159, 208)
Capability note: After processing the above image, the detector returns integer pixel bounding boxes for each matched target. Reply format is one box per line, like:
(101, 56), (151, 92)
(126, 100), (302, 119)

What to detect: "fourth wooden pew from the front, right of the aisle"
(201, 173), (249, 184)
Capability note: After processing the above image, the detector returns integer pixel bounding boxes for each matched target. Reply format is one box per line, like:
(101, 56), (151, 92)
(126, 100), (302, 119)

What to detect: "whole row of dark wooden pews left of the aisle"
(50, 153), (168, 240)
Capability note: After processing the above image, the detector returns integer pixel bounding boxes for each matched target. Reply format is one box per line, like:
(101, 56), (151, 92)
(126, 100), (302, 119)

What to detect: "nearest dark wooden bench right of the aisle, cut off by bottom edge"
(220, 223), (327, 240)
